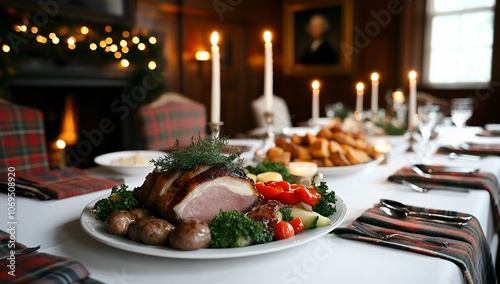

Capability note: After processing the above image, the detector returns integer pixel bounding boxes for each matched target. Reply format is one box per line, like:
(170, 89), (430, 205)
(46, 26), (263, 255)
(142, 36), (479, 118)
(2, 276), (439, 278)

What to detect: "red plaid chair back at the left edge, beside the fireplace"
(0, 100), (49, 175)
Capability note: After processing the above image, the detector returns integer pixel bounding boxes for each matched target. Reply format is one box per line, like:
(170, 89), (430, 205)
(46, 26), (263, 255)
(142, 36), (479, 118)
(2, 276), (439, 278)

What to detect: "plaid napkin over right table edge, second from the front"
(388, 168), (500, 233)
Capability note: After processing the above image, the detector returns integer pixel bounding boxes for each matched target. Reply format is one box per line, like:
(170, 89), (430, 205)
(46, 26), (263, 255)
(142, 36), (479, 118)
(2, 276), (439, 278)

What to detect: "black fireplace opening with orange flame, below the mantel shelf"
(12, 79), (141, 168)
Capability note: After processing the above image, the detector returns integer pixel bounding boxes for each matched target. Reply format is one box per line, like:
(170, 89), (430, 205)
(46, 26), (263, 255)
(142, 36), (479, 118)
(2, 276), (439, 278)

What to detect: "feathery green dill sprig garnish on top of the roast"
(151, 135), (242, 171)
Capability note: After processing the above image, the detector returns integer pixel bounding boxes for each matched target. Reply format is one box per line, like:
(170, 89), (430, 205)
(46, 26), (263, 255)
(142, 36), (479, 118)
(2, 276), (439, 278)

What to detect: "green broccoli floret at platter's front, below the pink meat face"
(210, 210), (273, 248)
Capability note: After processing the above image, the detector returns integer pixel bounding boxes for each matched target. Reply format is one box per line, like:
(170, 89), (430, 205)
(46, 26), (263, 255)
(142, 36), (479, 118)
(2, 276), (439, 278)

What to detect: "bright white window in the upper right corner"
(423, 0), (495, 86)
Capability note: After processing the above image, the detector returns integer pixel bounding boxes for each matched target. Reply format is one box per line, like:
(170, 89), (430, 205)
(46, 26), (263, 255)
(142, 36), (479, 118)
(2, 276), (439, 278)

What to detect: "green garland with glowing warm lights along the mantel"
(0, 7), (167, 103)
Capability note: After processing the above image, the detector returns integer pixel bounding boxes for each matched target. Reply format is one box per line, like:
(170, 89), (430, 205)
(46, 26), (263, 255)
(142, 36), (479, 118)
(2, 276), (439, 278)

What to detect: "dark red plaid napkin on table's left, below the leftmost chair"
(2, 167), (123, 200)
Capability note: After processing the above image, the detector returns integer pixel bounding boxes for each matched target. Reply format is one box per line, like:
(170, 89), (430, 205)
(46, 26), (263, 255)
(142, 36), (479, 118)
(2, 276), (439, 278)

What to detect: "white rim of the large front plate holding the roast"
(80, 195), (347, 259)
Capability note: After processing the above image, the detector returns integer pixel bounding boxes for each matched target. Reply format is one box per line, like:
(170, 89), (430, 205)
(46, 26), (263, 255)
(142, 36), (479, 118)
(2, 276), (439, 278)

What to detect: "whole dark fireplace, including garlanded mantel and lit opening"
(0, 0), (166, 168)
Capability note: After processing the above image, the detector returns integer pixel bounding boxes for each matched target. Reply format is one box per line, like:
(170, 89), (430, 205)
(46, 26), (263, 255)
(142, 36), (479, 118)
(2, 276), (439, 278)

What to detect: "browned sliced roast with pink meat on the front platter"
(134, 166), (259, 223)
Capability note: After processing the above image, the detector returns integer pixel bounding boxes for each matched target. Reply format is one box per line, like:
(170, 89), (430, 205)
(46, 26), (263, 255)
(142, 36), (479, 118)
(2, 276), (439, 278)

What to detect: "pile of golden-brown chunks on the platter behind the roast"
(266, 125), (380, 167)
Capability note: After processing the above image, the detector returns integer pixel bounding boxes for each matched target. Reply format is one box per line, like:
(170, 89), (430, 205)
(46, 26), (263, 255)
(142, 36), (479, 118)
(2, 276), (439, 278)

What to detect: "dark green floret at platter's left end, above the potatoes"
(93, 184), (139, 221)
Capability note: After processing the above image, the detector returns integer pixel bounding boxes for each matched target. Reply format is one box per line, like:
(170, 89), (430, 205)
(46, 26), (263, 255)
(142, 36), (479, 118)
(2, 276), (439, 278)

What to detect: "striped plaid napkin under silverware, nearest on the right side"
(334, 204), (497, 284)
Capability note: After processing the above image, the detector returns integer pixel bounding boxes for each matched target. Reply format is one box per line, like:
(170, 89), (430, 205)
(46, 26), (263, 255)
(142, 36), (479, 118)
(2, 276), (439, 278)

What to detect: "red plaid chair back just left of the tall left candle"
(138, 93), (207, 150)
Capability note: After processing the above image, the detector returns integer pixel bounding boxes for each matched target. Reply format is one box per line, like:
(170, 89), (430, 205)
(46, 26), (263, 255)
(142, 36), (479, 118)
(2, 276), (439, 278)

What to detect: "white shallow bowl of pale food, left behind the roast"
(94, 150), (167, 176)
